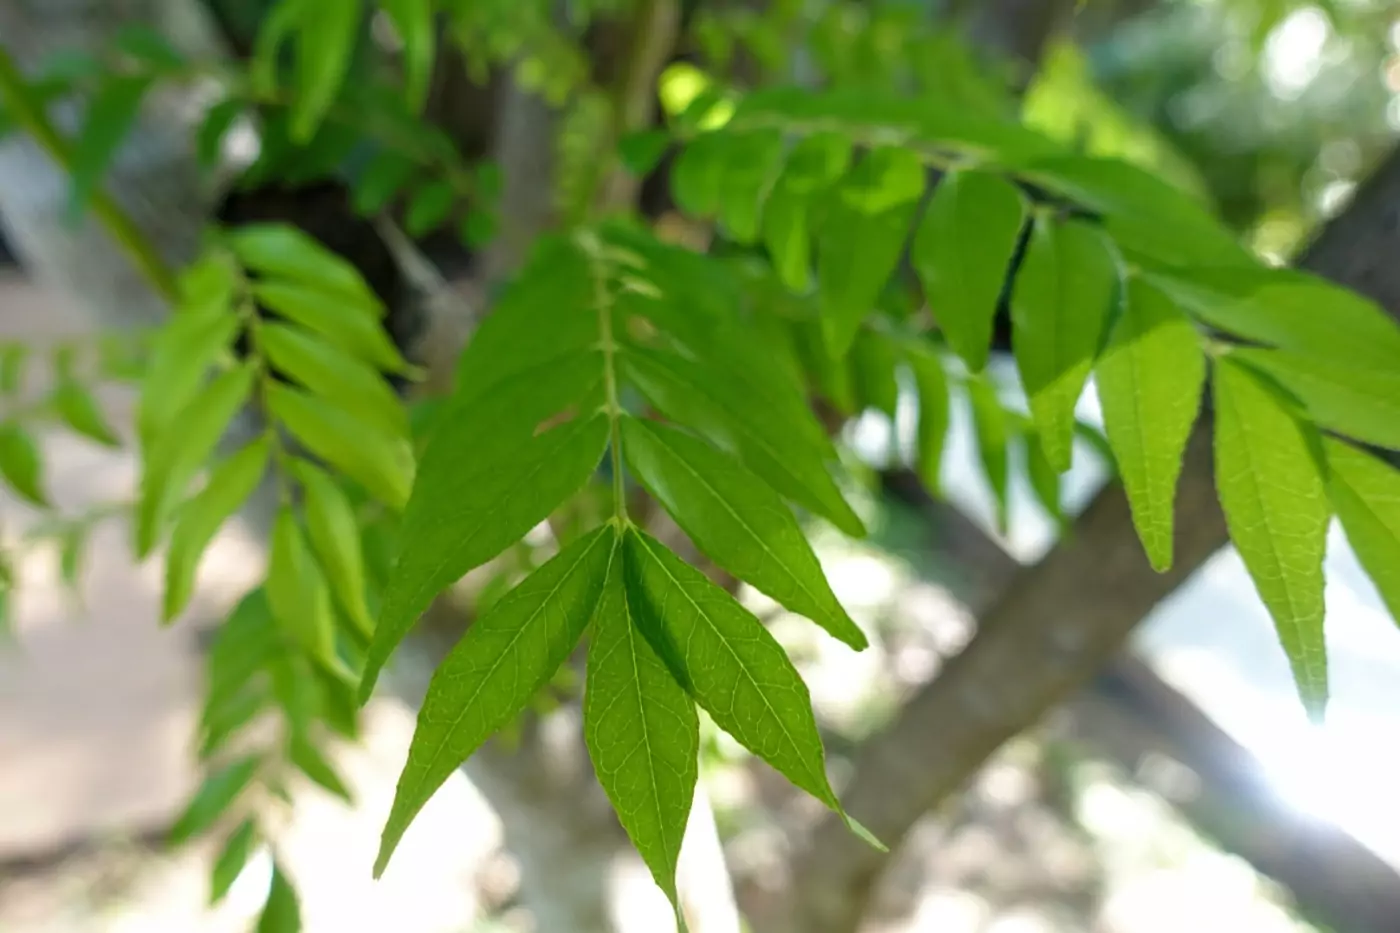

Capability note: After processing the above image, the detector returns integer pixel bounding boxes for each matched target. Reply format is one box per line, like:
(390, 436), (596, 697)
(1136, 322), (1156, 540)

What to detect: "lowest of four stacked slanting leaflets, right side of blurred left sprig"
(265, 384), (414, 509)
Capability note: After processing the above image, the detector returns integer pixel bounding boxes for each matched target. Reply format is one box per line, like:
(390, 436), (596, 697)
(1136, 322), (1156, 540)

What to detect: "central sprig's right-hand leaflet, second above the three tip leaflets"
(623, 352), (865, 538)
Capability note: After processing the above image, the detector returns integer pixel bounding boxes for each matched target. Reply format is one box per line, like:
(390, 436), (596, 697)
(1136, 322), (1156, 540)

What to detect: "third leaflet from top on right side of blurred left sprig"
(258, 324), (409, 437)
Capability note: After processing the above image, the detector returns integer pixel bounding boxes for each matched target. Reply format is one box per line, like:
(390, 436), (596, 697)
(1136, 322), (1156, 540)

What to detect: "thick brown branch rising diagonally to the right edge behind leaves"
(792, 151), (1400, 933)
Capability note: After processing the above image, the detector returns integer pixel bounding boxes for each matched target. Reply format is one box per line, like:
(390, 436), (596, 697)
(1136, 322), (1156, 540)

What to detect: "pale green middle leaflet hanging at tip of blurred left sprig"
(266, 507), (337, 667)
